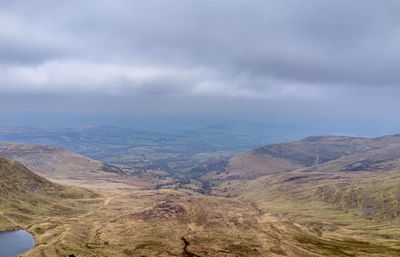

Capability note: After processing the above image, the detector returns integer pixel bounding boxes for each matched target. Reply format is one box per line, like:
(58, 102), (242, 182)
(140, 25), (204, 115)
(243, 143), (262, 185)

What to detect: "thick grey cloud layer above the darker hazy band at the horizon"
(0, 0), (400, 102)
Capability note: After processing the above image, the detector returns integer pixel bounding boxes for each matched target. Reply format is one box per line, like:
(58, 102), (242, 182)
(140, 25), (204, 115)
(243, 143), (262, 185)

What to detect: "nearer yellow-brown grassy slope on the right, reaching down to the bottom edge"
(215, 169), (400, 256)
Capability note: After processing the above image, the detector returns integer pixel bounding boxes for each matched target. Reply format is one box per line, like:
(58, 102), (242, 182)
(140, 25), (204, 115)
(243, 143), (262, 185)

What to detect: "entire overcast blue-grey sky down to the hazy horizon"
(0, 0), (400, 134)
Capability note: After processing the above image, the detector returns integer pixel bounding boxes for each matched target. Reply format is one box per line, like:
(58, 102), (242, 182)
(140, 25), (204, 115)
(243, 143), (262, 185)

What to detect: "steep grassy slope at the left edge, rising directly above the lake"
(0, 157), (97, 229)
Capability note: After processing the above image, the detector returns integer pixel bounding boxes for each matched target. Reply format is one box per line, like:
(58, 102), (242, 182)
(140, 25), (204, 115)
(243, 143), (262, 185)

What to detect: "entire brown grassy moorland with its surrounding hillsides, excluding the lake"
(0, 136), (400, 254)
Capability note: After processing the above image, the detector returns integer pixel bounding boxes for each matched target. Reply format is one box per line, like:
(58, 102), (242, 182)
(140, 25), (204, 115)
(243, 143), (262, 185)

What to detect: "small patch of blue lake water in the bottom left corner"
(0, 230), (35, 257)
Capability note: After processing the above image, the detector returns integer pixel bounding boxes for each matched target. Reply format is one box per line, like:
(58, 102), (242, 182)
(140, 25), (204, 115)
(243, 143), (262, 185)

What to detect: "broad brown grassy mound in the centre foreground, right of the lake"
(26, 190), (332, 257)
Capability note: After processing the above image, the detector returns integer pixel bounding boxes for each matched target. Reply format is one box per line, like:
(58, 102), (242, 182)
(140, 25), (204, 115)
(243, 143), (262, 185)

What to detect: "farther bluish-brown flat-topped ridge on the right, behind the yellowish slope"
(200, 135), (400, 180)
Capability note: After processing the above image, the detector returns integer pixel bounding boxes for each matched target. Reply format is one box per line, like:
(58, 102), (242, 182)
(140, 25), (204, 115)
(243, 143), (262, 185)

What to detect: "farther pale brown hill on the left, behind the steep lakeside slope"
(0, 143), (168, 190)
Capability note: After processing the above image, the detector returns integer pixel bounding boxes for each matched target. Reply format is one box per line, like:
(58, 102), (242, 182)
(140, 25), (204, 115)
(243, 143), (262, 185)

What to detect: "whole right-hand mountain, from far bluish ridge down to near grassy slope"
(200, 135), (400, 256)
